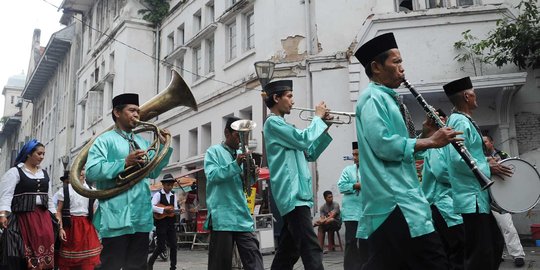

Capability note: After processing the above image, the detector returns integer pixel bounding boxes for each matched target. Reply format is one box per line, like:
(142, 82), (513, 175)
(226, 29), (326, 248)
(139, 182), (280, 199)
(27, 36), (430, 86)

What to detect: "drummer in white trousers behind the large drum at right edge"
(484, 135), (525, 267)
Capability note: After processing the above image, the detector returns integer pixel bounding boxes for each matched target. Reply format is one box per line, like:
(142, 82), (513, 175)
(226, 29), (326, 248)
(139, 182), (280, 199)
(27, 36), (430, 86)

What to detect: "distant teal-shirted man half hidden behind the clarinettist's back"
(338, 142), (368, 270)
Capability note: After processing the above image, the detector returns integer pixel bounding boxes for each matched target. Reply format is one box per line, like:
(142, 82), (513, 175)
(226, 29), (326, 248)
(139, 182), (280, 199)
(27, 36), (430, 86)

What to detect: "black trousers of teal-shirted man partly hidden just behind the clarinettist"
(431, 205), (465, 270)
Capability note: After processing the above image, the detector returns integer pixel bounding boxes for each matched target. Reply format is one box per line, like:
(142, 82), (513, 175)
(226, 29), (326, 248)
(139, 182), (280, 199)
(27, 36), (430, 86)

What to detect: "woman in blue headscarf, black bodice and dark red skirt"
(0, 139), (55, 270)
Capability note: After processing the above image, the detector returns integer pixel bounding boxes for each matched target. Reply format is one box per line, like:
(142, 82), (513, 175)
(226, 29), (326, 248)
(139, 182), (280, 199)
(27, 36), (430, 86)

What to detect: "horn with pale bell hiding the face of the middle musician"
(231, 120), (257, 197)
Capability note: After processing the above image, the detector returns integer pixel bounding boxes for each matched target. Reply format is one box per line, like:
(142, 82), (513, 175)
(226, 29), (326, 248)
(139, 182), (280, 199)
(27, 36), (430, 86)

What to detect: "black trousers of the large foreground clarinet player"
(362, 207), (448, 270)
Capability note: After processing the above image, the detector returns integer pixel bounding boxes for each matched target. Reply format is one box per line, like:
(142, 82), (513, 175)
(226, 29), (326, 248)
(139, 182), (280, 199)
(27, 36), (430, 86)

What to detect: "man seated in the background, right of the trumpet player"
(315, 190), (341, 250)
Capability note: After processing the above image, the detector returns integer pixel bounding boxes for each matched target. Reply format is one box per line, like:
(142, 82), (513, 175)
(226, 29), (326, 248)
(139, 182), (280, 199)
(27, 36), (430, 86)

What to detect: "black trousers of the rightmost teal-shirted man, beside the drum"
(461, 212), (504, 270)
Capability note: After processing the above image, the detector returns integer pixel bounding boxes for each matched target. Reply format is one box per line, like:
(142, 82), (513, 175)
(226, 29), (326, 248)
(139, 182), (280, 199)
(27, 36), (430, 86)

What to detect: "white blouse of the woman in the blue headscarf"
(0, 162), (56, 214)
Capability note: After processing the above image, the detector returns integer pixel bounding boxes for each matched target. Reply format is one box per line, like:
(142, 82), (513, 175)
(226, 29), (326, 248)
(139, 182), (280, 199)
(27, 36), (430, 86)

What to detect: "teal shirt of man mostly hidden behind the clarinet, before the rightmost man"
(421, 145), (463, 227)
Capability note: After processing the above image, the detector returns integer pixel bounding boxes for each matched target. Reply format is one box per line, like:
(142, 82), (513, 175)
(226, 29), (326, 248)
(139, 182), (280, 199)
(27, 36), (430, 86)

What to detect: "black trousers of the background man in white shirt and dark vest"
(148, 217), (177, 270)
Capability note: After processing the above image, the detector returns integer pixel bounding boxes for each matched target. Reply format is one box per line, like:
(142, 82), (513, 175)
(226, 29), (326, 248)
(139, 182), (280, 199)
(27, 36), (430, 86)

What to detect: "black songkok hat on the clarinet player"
(354, 33), (397, 67)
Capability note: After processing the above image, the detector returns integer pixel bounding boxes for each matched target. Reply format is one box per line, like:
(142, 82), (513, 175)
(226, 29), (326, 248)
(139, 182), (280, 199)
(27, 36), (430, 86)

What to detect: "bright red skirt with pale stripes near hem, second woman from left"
(58, 216), (102, 269)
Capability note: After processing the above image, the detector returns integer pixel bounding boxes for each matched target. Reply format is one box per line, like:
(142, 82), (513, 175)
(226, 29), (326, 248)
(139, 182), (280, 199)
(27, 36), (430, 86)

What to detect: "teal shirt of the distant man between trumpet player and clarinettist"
(338, 164), (362, 221)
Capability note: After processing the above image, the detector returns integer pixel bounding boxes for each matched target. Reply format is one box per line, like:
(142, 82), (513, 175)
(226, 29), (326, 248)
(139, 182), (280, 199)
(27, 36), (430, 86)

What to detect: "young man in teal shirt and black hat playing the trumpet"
(263, 80), (332, 270)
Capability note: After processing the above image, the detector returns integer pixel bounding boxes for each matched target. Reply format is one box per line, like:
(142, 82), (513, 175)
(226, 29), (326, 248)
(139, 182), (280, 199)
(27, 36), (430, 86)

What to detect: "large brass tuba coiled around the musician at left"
(69, 70), (197, 199)
